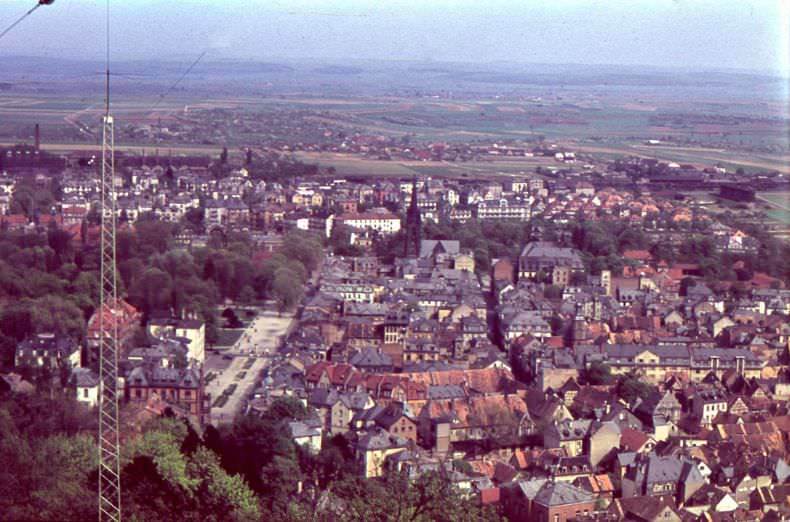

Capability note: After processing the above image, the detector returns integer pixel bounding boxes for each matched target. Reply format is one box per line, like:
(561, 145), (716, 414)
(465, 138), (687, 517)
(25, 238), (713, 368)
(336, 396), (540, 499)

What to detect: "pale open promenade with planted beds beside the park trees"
(206, 311), (293, 425)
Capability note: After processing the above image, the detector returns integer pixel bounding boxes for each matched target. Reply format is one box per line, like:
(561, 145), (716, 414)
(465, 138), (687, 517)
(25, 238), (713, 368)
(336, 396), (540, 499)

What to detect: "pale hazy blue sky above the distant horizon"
(0, 0), (790, 75)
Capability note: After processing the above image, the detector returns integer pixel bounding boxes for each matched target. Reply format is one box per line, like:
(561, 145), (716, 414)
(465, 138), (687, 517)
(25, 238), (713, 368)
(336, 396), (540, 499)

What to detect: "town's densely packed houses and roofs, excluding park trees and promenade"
(0, 137), (790, 522)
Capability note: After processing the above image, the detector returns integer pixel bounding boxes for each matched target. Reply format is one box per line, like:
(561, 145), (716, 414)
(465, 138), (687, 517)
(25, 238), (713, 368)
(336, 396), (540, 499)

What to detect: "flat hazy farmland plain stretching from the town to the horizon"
(0, 59), (790, 177)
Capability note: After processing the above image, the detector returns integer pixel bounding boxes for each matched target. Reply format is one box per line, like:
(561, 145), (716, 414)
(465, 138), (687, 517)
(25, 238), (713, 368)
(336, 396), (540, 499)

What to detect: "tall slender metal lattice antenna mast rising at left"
(99, 0), (121, 522)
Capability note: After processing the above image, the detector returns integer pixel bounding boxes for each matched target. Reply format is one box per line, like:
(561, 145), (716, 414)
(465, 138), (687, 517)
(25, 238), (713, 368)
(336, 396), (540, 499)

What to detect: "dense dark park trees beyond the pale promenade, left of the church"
(0, 218), (323, 365)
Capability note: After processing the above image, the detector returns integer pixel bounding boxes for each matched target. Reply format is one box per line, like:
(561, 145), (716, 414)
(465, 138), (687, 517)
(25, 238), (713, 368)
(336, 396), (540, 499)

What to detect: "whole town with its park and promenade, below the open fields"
(0, 127), (790, 522)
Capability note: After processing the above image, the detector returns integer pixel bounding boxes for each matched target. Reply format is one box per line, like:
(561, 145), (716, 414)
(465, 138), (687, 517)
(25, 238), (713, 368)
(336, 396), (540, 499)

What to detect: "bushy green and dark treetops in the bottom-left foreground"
(0, 395), (499, 522)
